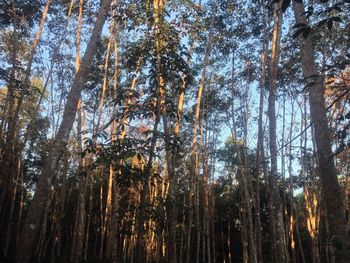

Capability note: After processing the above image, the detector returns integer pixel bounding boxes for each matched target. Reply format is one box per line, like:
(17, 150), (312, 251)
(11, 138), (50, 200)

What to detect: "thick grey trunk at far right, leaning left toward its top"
(293, 1), (350, 262)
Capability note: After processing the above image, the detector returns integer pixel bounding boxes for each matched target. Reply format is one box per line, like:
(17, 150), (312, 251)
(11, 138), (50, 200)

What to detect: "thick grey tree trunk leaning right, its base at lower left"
(16, 0), (111, 263)
